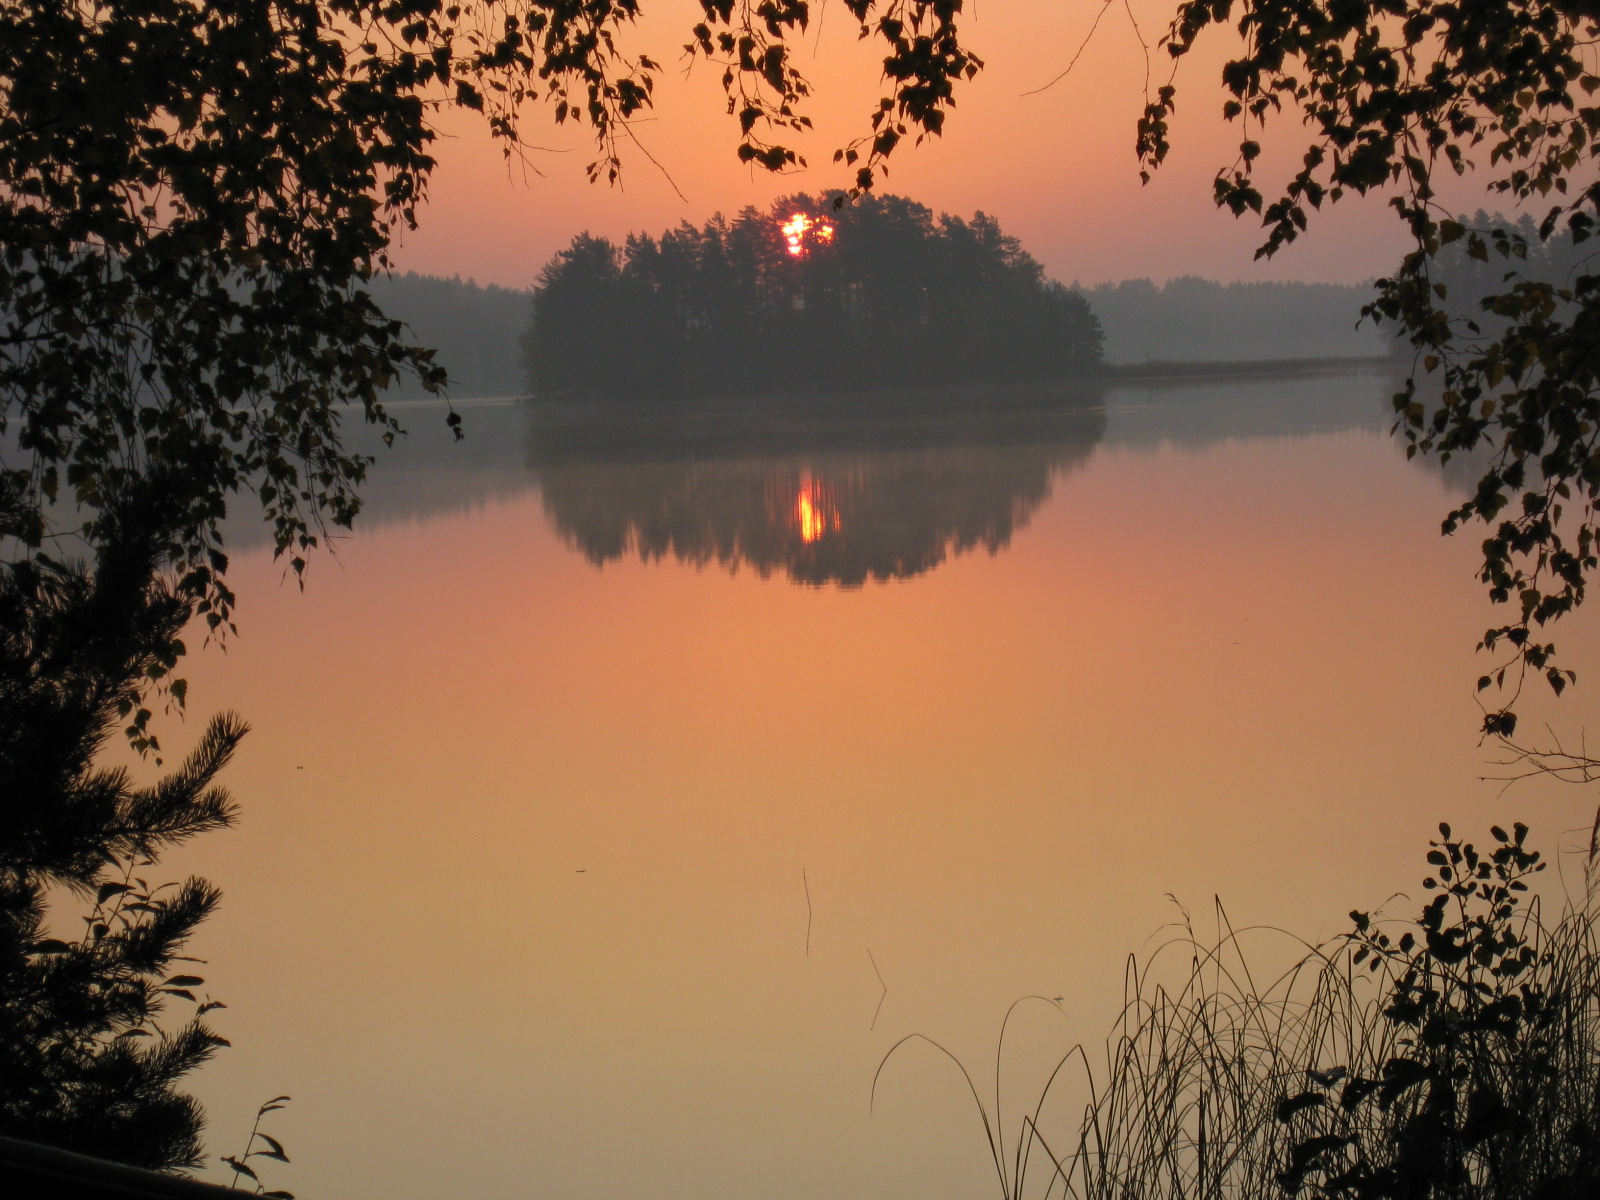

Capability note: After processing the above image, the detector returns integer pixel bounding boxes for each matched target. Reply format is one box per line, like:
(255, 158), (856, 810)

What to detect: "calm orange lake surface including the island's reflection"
(150, 376), (1595, 1200)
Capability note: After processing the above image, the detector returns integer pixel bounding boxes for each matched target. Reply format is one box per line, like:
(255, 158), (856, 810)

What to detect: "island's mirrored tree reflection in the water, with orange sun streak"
(539, 410), (1106, 587)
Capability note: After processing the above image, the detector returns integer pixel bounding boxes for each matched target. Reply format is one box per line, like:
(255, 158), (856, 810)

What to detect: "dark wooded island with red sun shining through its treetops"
(523, 195), (1102, 397)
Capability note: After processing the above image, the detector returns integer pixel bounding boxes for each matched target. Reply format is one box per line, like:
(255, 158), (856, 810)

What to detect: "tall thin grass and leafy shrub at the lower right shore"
(874, 826), (1600, 1200)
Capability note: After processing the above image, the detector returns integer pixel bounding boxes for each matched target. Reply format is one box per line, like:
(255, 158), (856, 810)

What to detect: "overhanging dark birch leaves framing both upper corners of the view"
(15, 0), (1600, 733)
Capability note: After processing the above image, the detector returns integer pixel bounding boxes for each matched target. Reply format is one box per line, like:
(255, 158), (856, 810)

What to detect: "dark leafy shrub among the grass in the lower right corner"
(1277, 824), (1600, 1200)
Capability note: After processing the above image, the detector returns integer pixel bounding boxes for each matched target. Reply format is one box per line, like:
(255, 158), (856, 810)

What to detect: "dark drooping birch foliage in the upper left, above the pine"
(0, 0), (940, 626)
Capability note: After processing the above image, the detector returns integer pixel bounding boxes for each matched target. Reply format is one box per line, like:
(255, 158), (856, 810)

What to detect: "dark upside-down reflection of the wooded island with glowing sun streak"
(530, 394), (1106, 587)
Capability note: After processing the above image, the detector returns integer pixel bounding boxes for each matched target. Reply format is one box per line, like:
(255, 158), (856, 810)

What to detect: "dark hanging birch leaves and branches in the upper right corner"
(1138, 0), (1600, 736)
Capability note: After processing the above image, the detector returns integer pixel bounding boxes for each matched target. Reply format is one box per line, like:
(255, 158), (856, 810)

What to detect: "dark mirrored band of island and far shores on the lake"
(243, 371), (1420, 563)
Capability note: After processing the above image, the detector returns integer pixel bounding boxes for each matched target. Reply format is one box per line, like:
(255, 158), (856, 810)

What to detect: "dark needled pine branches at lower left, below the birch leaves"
(0, 486), (245, 1170)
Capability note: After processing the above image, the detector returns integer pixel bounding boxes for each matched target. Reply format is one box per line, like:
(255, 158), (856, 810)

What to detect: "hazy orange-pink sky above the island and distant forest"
(397, 0), (1459, 286)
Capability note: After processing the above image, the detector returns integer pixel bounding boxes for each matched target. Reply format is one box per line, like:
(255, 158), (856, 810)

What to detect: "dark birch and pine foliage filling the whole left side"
(0, 0), (976, 1166)
